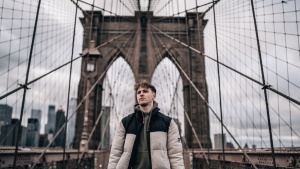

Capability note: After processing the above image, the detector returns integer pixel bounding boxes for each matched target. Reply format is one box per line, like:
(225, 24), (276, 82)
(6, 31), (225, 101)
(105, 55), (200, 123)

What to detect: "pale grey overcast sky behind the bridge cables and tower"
(0, 0), (300, 147)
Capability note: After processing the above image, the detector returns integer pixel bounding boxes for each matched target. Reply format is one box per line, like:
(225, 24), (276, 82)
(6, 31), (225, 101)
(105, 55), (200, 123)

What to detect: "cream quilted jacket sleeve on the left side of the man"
(107, 121), (125, 169)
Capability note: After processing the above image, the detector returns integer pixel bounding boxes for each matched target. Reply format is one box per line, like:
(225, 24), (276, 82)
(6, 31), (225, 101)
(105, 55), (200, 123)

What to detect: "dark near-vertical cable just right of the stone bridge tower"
(213, 0), (225, 168)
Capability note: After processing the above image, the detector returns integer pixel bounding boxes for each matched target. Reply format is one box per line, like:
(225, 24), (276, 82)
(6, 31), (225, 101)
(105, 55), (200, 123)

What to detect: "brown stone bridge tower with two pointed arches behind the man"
(73, 11), (212, 149)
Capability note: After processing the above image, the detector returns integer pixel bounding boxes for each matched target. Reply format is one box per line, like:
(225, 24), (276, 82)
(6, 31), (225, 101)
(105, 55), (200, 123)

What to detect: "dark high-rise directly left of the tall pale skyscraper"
(54, 109), (65, 147)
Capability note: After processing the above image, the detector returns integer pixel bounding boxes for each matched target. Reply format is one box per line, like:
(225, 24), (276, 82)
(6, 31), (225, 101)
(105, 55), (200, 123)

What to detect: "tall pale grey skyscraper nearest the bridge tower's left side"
(66, 98), (77, 148)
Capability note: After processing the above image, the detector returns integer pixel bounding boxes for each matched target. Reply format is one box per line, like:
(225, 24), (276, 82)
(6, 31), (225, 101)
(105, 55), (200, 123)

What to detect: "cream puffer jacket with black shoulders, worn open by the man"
(108, 103), (184, 169)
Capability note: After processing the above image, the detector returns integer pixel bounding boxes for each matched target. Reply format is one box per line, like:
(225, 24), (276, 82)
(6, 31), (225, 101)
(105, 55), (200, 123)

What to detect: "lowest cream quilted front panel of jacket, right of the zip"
(151, 150), (171, 169)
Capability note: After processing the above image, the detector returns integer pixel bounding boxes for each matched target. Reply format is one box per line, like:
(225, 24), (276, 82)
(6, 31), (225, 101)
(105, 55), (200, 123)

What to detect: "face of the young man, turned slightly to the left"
(136, 87), (156, 106)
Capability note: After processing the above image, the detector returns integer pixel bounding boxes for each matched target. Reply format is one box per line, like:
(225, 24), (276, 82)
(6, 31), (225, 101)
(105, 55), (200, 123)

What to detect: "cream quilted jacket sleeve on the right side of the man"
(167, 119), (184, 169)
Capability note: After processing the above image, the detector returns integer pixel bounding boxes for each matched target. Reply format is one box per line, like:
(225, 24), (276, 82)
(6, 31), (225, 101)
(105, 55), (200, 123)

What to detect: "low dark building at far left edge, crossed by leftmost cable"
(0, 119), (27, 146)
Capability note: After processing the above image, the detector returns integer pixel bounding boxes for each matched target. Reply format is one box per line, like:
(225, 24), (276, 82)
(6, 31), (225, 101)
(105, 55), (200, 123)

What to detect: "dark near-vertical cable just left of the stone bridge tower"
(63, 0), (78, 168)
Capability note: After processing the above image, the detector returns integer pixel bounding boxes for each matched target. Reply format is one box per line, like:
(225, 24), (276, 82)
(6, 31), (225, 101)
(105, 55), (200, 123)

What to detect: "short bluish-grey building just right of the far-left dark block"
(26, 118), (40, 147)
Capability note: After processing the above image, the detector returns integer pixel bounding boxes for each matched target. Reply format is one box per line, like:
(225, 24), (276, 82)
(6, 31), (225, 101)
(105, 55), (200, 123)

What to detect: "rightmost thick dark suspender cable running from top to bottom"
(251, 0), (276, 169)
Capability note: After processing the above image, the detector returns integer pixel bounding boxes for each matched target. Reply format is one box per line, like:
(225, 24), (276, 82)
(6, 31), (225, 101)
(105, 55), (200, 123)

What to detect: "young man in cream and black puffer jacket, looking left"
(108, 81), (184, 169)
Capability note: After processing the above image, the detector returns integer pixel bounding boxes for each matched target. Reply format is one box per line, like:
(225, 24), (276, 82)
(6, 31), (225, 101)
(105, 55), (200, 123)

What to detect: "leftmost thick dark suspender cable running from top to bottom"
(13, 0), (41, 169)
